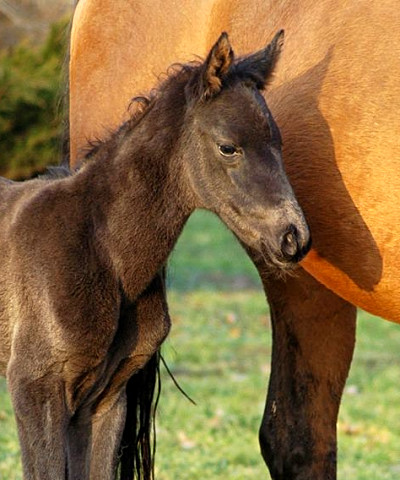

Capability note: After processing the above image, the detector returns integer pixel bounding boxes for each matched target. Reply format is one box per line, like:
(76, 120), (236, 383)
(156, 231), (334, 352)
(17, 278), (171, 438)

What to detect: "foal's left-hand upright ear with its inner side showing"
(191, 32), (234, 99)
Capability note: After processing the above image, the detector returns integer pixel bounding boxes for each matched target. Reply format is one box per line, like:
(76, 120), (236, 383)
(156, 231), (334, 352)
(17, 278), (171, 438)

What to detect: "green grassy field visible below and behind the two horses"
(0, 212), (400, 480)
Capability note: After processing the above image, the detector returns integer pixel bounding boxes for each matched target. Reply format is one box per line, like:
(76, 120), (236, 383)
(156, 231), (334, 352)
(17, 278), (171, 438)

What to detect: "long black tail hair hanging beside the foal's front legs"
(118, 351), (161, 480)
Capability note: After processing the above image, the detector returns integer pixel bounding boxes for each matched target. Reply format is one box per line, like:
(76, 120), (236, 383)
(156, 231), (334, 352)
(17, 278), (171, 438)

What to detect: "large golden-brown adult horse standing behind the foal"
(70, 0), (400, 480)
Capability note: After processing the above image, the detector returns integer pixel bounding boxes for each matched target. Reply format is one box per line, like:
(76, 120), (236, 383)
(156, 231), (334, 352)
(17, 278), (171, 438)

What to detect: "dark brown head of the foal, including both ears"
(182, 32), (310, 266)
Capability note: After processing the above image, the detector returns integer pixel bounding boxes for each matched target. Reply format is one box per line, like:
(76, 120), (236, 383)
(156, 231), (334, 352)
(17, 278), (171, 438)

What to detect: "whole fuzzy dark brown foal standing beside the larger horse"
(0, 36), (309, 480)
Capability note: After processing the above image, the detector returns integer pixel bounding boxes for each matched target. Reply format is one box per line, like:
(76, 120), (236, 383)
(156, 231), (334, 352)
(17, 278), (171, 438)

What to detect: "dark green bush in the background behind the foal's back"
(0, 20), (68, 178)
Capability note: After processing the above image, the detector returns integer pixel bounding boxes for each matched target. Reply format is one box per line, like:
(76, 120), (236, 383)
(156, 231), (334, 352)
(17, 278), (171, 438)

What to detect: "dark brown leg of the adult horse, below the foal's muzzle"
(255, 265), (356, 480)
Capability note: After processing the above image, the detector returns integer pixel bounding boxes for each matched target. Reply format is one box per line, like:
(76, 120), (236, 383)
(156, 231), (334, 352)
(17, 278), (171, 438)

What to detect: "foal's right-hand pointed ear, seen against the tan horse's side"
(236, 30), (284, 90)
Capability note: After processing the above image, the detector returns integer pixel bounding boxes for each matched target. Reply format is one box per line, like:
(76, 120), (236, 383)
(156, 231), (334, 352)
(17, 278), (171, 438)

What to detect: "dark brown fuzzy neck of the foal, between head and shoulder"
(82, 87), (193, 300)
